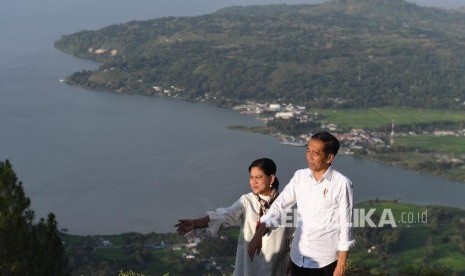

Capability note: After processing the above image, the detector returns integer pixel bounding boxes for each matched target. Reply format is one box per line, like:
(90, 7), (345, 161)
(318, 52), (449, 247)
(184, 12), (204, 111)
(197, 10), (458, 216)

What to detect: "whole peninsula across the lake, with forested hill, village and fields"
(55, 0), (465, 182)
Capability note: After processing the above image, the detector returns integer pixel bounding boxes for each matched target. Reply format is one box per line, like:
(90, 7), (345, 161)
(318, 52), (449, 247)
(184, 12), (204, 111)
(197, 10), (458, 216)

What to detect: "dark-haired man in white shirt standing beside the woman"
(248, 132), (355, 276)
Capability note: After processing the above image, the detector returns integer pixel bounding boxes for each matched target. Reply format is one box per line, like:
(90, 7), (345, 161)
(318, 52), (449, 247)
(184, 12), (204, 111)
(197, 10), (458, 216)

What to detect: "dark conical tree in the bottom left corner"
(0, 160), (67, 276)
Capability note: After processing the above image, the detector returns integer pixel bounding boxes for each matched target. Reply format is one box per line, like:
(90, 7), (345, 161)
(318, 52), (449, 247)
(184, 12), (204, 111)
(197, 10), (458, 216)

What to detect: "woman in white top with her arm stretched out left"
(175, 158), (294, 276)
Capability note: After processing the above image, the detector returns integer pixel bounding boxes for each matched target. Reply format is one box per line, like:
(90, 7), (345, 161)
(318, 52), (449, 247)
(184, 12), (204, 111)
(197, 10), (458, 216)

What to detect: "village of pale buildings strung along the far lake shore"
(152, 85), (465, 164)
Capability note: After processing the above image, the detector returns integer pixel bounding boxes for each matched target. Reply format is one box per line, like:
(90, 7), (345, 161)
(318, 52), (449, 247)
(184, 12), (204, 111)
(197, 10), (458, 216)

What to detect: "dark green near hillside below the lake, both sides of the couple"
(63, 200), (465, 276)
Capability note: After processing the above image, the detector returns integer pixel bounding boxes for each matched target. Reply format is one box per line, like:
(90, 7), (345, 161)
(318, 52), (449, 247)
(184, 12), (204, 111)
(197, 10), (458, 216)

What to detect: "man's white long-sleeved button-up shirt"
(260, 167), (355, 268)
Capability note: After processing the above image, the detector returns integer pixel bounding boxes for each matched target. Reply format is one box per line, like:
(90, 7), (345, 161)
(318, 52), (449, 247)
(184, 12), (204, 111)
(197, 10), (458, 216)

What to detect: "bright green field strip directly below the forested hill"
(311, 107), (465, 129)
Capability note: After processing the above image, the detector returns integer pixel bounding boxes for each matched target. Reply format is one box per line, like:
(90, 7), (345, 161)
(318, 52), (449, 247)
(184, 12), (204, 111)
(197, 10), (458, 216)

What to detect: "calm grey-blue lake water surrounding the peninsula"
(0, 0), (465, 234)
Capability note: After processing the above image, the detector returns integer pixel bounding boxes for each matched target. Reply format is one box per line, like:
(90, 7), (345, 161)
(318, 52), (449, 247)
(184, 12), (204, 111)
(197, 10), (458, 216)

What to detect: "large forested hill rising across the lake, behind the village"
(55, 0), (465, 109)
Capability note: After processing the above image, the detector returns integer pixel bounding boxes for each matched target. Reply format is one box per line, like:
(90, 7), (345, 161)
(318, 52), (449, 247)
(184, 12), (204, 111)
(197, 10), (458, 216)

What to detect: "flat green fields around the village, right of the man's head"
(310, 107), (465, 183)
